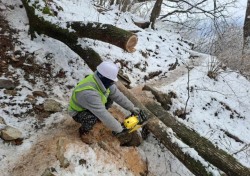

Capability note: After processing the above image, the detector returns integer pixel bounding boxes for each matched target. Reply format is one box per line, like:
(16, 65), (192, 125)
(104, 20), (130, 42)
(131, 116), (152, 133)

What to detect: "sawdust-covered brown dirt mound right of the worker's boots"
(78, 107), (147, 176)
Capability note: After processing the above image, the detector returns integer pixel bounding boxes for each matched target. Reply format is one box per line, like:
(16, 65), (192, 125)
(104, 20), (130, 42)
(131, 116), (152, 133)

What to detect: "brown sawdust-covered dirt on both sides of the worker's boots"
(9, 108), (147, 176)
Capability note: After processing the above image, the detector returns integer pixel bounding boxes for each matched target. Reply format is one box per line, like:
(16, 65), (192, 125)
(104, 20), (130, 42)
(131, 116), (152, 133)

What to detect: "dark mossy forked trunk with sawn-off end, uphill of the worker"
(22, 0), (137, 86)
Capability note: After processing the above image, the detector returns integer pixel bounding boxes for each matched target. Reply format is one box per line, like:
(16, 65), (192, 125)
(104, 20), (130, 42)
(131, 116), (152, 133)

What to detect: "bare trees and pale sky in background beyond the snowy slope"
(95, 0), (250, 77)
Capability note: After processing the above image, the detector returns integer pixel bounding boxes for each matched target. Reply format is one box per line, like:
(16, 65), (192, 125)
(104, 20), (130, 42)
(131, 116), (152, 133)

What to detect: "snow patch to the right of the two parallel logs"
(158, 58), (250, 167)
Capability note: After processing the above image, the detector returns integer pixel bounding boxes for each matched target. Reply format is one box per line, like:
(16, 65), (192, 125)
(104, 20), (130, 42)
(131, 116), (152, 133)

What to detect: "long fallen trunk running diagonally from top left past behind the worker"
(22, 0), (250, 175)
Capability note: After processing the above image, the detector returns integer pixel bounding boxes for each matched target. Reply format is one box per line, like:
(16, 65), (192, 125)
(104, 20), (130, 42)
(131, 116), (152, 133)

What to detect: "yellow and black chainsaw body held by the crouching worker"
(123, 110), (148, 133)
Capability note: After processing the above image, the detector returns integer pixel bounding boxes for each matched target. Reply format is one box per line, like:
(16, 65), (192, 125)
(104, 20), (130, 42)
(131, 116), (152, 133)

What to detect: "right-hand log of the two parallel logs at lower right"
(144, 86), (250, 176)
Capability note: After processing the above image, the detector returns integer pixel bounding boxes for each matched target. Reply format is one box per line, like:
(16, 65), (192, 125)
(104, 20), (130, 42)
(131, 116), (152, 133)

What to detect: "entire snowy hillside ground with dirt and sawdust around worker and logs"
(0, 0), (250, 176)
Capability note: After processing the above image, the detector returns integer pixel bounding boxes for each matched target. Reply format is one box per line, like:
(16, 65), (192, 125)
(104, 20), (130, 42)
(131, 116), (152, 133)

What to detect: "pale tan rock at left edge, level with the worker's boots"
(1, 126), (22, 141)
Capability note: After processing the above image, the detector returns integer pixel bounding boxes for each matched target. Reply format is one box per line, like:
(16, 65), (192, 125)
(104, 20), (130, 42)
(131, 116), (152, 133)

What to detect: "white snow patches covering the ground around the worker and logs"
(0, 0), (250, 176)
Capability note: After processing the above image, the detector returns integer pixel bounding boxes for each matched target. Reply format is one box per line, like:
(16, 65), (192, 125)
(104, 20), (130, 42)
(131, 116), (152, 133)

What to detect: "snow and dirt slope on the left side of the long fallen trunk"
(0, 1), (192, 175)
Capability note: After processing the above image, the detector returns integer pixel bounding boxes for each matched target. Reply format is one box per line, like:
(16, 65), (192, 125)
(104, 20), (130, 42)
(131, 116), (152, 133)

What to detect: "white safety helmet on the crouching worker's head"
(97, 61), (119, 81)
